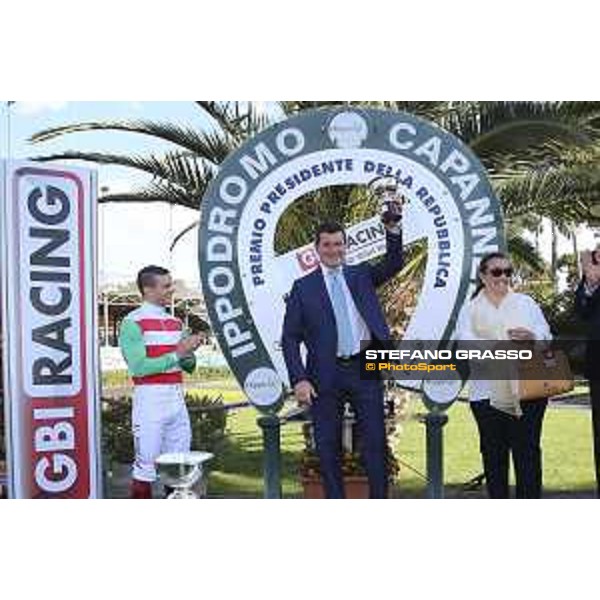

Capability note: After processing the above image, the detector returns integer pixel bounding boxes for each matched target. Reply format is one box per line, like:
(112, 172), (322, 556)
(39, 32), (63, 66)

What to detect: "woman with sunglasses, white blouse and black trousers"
(457, 252), (551, 498)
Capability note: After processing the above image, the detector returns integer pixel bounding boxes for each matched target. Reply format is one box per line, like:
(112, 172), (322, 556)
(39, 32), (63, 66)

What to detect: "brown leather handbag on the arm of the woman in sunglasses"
(519, 350), (575, 400)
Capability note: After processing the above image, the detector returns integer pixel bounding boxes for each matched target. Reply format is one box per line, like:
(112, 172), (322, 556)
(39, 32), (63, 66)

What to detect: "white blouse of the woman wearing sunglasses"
(454, 291), (552, 402)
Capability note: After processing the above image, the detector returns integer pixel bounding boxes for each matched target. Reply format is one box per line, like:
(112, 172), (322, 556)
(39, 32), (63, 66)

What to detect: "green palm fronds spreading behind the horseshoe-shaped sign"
(32, 101), (600, 324)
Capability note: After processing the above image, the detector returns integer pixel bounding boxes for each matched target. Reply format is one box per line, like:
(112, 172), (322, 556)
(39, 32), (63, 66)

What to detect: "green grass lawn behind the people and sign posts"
(202, 388), (595, 498)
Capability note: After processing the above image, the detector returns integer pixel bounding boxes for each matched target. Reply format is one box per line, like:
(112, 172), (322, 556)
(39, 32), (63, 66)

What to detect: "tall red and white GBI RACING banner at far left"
(0, 162), (101, 498)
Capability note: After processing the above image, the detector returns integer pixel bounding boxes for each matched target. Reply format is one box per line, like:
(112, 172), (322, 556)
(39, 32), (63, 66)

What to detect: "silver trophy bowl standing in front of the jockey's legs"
(156, 452), (214, 500)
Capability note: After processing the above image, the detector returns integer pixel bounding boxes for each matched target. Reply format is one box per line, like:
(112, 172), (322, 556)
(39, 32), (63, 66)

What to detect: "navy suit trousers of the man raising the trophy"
(311, 360), (388, 499)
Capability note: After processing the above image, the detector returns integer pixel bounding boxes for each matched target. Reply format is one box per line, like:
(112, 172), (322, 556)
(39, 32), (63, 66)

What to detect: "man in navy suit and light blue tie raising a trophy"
(282, 222), (403, 498)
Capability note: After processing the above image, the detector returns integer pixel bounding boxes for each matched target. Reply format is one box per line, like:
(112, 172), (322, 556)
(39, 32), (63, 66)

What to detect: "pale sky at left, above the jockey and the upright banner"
(0, 102), (214, 287)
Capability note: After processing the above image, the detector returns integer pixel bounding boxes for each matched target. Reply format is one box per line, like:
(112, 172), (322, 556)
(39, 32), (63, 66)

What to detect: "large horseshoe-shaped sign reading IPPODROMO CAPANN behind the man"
(199, 107), (505, 411)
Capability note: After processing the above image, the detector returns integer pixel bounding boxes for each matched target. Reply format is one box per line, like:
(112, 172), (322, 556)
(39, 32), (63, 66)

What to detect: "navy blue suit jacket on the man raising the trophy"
(281, 233), (403, 393)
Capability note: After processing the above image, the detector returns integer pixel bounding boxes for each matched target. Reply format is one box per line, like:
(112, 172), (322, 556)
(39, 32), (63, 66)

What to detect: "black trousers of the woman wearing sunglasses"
(471, 399), (548, 499)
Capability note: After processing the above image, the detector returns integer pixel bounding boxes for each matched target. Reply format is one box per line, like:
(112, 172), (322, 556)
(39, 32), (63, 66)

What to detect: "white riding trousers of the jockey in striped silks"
(132, 385), (192, 482)
